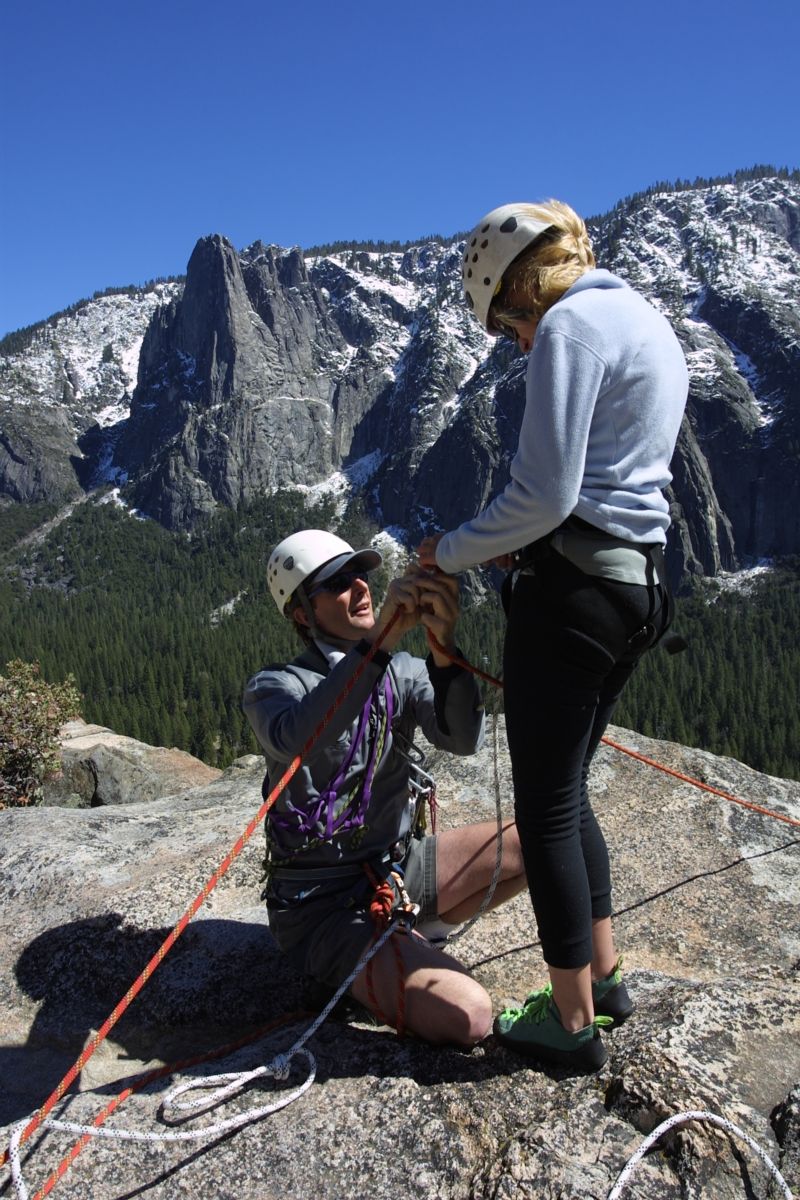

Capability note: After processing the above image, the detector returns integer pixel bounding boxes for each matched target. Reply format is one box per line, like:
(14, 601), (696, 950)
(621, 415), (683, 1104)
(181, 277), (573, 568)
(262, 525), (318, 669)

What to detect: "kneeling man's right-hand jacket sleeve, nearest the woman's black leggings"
(397, 655), (485, 755)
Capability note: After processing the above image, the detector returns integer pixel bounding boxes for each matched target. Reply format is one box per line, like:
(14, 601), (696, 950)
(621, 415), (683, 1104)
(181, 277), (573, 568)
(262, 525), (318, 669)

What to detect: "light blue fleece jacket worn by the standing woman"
(437, 270), (688, 574)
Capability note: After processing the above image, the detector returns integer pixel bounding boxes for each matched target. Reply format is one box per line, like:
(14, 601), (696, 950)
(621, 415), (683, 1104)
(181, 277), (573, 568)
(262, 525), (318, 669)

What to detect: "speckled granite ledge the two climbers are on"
(0, 719), (800, 1200)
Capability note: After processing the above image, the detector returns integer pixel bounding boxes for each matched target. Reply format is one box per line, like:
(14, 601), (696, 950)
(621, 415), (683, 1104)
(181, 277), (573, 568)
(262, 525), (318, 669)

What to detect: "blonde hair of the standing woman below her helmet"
(489, 200), (595, 328)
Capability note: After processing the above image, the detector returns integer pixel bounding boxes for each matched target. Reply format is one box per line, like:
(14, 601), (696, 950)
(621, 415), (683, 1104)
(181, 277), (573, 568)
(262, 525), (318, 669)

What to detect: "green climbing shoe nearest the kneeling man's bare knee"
(494, 988), (610, 1072)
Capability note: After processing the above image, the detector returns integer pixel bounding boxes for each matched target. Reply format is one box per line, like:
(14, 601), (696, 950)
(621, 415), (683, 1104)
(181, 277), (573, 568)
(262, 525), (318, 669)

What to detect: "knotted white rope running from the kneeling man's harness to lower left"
(2, 918), (403, 1200)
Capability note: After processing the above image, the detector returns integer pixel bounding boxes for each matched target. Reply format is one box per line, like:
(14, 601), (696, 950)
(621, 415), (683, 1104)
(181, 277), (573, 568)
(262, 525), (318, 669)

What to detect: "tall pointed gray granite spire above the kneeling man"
(116, 236), (345, 528)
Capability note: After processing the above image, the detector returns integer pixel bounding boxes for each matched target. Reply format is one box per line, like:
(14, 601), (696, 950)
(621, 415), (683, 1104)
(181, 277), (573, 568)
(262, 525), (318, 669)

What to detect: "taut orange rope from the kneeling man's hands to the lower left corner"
(0, 610), (399, 1176)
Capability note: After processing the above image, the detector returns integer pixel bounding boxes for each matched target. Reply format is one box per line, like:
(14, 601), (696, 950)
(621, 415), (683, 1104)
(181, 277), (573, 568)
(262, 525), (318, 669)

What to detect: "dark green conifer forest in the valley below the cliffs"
(0, 492), (800, 779)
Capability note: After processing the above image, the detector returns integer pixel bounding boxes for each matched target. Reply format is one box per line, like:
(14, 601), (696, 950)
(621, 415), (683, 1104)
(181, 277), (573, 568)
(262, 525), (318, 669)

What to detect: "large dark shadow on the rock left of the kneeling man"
(0, 913), (303, 1123)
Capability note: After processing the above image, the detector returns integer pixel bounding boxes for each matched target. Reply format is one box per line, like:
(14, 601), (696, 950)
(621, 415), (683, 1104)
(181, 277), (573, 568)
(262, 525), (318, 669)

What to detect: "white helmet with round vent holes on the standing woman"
(462, 203), (552, 332)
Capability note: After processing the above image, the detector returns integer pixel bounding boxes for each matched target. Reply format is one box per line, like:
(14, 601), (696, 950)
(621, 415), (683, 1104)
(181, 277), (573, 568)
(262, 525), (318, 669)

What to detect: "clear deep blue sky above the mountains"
(0, 0), (800, 335)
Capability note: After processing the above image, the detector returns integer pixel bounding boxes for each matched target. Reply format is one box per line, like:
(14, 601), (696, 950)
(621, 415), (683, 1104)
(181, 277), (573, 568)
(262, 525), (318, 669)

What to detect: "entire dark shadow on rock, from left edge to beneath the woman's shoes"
(6, 913), (537, 1124)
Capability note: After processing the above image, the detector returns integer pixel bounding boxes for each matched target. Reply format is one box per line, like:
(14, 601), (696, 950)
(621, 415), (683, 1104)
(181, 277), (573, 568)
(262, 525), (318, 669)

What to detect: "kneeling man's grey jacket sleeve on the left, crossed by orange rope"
(242, 642), (390, 762)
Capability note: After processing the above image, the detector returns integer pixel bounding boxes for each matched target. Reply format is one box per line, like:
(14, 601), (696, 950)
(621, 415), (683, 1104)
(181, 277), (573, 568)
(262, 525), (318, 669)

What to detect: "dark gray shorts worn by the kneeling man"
(267, 835), (438, 988)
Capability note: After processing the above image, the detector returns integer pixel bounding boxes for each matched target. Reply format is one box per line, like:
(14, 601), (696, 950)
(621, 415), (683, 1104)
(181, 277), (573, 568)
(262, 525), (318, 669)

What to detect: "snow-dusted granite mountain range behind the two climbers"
(0, 176), (800, 588)
